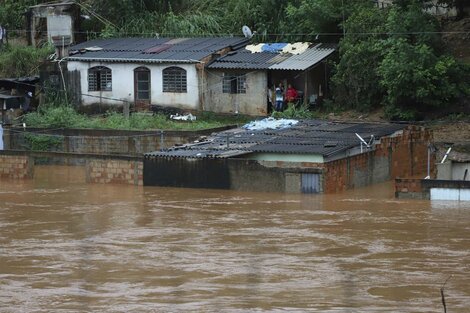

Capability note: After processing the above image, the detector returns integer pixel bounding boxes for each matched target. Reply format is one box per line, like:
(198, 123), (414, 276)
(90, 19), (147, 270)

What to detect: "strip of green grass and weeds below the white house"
(23, 105), (252, 130)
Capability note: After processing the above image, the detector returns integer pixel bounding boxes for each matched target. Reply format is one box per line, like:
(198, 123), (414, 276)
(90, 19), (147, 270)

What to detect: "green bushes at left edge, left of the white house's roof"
(0, 45), (53, 77)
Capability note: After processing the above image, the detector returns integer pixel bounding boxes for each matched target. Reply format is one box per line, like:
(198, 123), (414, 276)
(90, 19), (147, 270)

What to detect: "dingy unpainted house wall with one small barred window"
(204, 70), (268, 115)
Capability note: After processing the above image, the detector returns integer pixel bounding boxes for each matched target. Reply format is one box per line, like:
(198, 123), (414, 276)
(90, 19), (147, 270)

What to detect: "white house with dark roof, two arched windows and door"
(65, 37), (247, 110)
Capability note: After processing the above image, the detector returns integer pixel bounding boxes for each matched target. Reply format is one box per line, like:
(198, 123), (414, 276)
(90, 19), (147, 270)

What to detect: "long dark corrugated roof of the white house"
(67, 37), (248, 63)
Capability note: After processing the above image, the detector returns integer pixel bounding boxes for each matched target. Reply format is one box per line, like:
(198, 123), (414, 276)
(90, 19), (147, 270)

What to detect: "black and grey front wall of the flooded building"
(143, 157), (322, 193)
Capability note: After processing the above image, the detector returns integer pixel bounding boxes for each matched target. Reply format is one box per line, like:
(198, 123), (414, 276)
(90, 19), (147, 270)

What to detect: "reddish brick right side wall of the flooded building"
(324, 126), (435, 193)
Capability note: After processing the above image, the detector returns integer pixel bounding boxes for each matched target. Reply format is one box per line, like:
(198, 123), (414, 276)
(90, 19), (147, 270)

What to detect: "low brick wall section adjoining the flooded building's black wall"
(86, 159), (143, 186)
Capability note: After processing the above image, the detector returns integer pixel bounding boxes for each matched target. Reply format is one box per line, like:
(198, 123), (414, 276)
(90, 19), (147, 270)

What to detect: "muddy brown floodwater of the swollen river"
(0, 167), (470, 313)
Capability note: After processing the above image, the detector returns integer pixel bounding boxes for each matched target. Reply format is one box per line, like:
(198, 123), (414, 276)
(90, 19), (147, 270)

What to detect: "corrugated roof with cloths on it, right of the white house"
(208, 44), (335, 71)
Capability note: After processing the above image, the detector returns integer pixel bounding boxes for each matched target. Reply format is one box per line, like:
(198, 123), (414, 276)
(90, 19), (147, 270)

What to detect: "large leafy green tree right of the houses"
(332, 0), (470, 120)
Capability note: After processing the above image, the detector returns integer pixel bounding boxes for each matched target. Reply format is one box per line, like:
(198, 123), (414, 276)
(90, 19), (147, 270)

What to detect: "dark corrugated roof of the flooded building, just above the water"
(145, 120), (406, 159)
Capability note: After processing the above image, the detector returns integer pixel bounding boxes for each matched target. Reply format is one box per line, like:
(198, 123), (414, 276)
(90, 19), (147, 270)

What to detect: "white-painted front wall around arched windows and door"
(67, 61), (199, 110)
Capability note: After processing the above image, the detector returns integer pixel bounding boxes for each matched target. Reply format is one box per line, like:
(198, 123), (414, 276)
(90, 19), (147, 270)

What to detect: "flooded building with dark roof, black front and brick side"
(143, 120), (433, 193)
